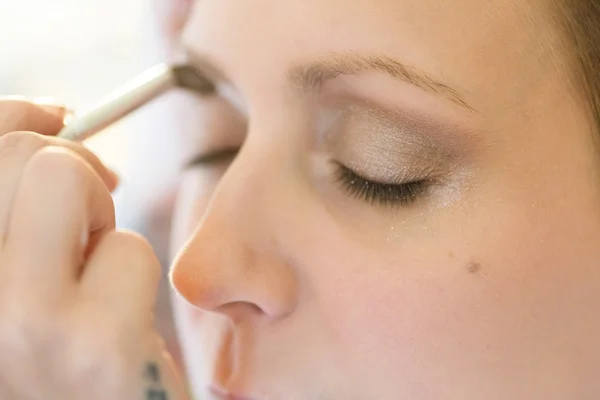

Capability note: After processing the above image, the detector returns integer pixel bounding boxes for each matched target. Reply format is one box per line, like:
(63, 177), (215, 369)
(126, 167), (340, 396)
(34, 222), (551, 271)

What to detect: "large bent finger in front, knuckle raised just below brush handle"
(0, 146), (115, 294)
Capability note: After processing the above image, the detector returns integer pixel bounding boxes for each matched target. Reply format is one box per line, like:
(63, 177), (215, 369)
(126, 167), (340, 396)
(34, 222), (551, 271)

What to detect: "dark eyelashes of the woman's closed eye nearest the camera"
(336, 163), (428, 206)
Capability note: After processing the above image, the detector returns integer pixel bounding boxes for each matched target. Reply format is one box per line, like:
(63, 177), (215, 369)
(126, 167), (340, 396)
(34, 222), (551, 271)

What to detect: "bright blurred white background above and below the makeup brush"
(0, 0), (149, 171)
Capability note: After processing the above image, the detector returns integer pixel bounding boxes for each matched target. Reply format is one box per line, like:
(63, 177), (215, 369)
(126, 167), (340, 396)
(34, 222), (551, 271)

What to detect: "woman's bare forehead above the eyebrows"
(185, 0), (552, 117)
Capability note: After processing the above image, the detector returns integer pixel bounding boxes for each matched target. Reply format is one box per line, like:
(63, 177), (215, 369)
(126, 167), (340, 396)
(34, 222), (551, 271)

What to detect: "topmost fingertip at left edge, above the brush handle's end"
(0, 98), (67, 136)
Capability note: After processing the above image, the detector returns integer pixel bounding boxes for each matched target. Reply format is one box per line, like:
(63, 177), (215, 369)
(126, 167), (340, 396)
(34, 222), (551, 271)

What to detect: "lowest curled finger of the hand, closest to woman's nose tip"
(80, 231), (161, 332)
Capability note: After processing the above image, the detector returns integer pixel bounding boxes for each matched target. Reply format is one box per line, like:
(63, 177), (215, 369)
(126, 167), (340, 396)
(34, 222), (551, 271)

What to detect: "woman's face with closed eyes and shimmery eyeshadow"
(165, 0), (600, 400)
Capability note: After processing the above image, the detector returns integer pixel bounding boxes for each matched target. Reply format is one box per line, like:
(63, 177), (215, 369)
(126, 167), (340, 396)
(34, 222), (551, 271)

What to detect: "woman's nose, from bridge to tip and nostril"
(171, 145), (298, 320)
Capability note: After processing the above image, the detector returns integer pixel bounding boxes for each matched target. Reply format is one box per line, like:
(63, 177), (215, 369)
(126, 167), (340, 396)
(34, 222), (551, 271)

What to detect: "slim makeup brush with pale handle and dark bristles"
(58, 64), (215, 142)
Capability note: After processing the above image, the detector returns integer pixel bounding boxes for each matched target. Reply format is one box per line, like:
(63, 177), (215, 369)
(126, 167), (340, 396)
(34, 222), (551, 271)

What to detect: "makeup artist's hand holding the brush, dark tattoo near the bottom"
(0, 100), (187, 400)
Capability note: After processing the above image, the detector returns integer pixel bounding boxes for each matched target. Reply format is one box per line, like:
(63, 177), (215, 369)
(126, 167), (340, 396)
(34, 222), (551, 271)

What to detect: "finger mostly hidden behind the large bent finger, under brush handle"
(0, 132), (118, 243)
